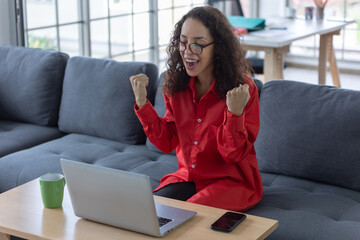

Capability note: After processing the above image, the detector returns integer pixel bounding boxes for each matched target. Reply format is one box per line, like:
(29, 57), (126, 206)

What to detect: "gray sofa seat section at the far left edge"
(0, 121), (63, 157)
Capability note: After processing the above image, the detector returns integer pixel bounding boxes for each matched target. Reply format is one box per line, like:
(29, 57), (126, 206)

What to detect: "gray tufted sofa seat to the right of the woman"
(247, 173), (360, 240)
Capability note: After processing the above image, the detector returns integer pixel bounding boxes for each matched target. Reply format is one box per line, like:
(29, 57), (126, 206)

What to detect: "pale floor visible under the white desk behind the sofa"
(256, 66), (360, 91)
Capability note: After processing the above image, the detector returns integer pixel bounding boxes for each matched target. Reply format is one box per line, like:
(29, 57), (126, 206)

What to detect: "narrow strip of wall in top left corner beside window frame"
(0, 0), (16, 45)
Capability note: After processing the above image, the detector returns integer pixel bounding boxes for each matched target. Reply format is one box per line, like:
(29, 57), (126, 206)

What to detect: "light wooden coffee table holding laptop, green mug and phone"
(0, 179), (278, 240)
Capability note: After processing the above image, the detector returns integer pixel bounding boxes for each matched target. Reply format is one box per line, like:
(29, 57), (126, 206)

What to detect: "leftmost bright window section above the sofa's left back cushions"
(23, 0), (81, 55)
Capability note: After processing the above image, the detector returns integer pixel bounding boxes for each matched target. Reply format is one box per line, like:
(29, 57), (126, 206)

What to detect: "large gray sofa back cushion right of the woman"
(255, 80), (360, 191)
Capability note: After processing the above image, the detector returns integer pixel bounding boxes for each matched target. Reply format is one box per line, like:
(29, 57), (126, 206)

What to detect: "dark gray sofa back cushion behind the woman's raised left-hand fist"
(59, 57), (158, 144)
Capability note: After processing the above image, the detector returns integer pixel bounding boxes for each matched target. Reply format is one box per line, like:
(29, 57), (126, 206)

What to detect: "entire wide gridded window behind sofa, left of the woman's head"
(22, 0), (206, 68)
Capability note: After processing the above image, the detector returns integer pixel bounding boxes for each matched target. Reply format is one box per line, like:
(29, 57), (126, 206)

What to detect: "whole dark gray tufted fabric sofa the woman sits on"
(0, 46), (360, 240)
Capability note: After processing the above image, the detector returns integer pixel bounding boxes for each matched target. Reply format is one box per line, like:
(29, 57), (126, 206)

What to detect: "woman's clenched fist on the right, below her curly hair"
(226, 84), (250, 115)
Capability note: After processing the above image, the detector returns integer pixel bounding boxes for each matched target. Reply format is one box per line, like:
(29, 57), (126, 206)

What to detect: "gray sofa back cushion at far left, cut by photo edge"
(0, 45), (68, 126)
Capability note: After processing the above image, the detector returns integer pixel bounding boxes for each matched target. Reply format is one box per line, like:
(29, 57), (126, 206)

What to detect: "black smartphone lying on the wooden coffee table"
(211, 212), (246, 232)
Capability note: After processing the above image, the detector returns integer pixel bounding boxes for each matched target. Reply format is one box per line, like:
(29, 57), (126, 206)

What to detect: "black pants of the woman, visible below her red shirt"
(154, 182), (196, 201)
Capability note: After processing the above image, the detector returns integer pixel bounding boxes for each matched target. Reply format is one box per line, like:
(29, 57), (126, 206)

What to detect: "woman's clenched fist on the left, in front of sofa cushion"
(130, 73), (149, 108)
